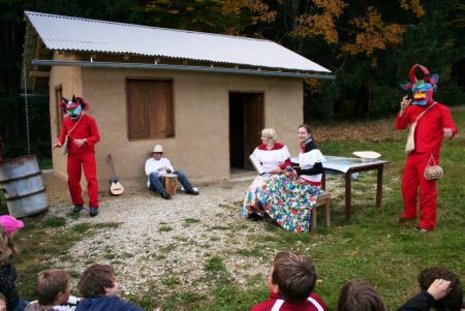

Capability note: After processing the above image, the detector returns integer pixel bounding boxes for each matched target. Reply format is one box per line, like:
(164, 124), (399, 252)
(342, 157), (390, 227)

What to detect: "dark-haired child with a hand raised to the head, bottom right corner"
(399, 267), (463, 311)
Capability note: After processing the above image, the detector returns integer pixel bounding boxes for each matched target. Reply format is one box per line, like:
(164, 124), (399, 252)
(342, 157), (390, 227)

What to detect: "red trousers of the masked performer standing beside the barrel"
(67, 152), (98, 207)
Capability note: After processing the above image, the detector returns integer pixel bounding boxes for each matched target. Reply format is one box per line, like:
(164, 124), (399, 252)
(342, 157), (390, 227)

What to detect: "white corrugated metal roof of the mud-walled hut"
(25, 11), (331, 73)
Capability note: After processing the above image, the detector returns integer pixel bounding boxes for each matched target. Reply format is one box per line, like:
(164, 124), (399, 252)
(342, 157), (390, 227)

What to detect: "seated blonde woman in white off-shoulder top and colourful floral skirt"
(241, 129), (319, 232)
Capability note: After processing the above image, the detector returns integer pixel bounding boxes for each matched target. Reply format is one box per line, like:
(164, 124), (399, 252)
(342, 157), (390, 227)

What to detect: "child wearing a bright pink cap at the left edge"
(0, 215), (27, 311)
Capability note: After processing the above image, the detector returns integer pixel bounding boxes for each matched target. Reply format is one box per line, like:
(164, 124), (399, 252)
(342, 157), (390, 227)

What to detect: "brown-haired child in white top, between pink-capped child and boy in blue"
(25, 269), (79, 311)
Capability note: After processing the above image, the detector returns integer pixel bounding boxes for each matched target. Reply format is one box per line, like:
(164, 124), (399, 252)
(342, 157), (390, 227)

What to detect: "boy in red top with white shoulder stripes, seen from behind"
(251, 252), (328, 311)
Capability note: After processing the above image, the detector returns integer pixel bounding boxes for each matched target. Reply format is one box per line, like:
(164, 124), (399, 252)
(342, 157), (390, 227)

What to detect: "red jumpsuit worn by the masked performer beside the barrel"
(58, 112), (100, 208)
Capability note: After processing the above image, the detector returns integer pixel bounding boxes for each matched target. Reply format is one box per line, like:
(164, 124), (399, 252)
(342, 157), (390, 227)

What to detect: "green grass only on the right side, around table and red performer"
(187, 111), (465, 310)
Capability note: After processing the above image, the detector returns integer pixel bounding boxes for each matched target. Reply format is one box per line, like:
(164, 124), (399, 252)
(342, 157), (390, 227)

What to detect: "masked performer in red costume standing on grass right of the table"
(395, 64), (457, 232)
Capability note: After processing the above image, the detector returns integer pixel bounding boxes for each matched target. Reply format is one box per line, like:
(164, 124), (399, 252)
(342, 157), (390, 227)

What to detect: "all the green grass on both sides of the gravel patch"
(6, 110), (465, 310)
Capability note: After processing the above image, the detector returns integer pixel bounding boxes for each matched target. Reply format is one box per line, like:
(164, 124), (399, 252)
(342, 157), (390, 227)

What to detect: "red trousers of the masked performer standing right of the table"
(402, 152), (439, 230)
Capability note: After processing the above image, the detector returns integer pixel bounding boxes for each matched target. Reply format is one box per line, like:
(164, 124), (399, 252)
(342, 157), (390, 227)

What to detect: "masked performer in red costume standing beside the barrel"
(53, 95), (100, 217)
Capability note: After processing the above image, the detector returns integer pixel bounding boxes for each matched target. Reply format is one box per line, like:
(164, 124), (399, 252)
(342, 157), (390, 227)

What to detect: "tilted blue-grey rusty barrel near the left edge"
(0, 155), (48, 218)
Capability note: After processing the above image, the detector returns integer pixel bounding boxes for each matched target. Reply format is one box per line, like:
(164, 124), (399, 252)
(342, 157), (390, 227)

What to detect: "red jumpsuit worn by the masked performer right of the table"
(395, 103), (457, 230)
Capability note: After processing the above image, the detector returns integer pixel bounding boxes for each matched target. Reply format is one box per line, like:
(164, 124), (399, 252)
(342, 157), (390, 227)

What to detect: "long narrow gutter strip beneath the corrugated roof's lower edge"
(32, 59), (336, 80)
